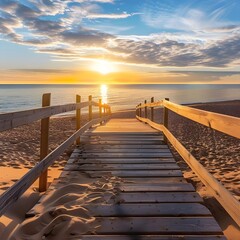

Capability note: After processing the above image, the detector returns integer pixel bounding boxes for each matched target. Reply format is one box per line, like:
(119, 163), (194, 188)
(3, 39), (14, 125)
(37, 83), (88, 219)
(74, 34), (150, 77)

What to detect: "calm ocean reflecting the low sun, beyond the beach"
(0, 84), (240, 113)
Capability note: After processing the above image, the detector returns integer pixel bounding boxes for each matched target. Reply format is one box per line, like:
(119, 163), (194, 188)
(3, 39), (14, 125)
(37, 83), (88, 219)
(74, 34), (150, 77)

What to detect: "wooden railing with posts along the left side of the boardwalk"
(0, 93), (111, 216)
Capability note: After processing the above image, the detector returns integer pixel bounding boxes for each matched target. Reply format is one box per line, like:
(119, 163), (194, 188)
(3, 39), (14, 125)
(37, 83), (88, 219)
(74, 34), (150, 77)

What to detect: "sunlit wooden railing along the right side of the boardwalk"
(136, 98), (240, 226)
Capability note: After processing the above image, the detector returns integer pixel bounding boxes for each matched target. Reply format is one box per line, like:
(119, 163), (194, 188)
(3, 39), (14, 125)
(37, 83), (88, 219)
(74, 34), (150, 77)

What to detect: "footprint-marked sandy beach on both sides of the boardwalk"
(0, 101), (240, 240)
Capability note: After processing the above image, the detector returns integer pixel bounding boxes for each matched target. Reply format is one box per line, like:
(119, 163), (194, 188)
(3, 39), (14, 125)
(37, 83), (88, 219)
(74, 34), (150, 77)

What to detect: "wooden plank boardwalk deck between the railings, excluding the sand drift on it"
(28, 119), (225, 240)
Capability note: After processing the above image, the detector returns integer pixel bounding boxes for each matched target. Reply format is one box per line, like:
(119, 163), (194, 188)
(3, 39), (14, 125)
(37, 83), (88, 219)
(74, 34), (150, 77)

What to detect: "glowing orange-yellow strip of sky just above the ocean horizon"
(0, 68), (240, 85)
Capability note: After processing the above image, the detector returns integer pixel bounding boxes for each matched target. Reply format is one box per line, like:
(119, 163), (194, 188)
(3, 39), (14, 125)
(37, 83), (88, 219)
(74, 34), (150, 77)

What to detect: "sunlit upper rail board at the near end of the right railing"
(163, 100), (240, 138)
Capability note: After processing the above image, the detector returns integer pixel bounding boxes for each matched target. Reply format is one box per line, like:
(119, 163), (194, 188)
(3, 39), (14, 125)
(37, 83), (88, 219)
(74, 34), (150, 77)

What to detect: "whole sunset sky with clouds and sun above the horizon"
(0, 0), (240, 84)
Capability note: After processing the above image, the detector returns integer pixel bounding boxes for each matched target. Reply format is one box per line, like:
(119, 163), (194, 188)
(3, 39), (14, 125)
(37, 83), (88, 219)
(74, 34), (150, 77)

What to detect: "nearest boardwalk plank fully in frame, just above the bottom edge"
(94, 217), (222, 235)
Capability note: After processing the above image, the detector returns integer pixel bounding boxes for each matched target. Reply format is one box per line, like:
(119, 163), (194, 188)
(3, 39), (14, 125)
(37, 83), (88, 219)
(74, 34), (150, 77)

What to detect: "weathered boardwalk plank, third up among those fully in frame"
(116, 192), (203, 203)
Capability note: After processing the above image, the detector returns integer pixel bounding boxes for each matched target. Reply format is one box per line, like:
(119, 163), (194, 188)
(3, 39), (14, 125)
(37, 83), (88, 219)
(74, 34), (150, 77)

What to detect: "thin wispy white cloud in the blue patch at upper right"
(141, 0), (237, 32)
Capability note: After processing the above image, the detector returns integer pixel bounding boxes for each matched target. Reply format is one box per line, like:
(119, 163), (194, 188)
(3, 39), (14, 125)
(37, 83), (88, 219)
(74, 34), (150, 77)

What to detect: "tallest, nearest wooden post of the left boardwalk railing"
(39, 93), (51, 192)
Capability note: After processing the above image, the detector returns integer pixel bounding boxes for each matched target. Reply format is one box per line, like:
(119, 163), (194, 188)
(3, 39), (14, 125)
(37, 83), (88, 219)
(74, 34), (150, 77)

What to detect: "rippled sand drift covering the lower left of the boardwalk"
(9, 176), (118, 240)
